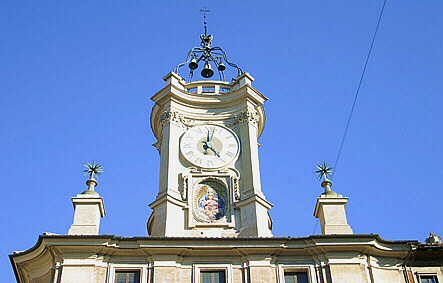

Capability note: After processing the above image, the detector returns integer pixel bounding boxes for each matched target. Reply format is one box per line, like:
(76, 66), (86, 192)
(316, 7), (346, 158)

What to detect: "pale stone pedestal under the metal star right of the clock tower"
(314, 179), (353, 235)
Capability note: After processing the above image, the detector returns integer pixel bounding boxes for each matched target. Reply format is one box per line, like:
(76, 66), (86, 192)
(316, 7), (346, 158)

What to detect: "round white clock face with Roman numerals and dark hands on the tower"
(180, 124), (240, 169)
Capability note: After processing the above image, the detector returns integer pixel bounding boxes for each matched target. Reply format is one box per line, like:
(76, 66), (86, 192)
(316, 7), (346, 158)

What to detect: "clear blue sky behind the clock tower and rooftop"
(0, 0), (443, 281)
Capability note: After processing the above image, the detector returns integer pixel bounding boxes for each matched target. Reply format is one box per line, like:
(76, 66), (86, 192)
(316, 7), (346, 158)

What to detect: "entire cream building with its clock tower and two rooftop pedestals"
(10, 33), (443, 283)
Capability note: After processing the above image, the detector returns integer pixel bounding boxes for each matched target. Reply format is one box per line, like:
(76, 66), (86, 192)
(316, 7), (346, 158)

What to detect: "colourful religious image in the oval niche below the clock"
(196, 181), (226, 222)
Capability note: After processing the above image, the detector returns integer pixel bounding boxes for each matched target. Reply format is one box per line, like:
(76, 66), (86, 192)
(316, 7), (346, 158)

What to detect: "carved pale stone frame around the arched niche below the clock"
(180, 168), (240, 229)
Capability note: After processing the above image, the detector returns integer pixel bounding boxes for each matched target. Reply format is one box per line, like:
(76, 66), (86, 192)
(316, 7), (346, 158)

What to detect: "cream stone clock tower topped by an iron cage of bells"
(147, 31), (272, 237)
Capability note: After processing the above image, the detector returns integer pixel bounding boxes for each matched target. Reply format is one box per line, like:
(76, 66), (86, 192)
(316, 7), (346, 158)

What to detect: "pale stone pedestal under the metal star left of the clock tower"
(68, 179), (105, 235)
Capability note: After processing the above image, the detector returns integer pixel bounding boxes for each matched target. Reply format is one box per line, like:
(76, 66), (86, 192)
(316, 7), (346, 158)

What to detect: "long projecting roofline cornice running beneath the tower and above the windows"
(9, 234), (420, 282)
